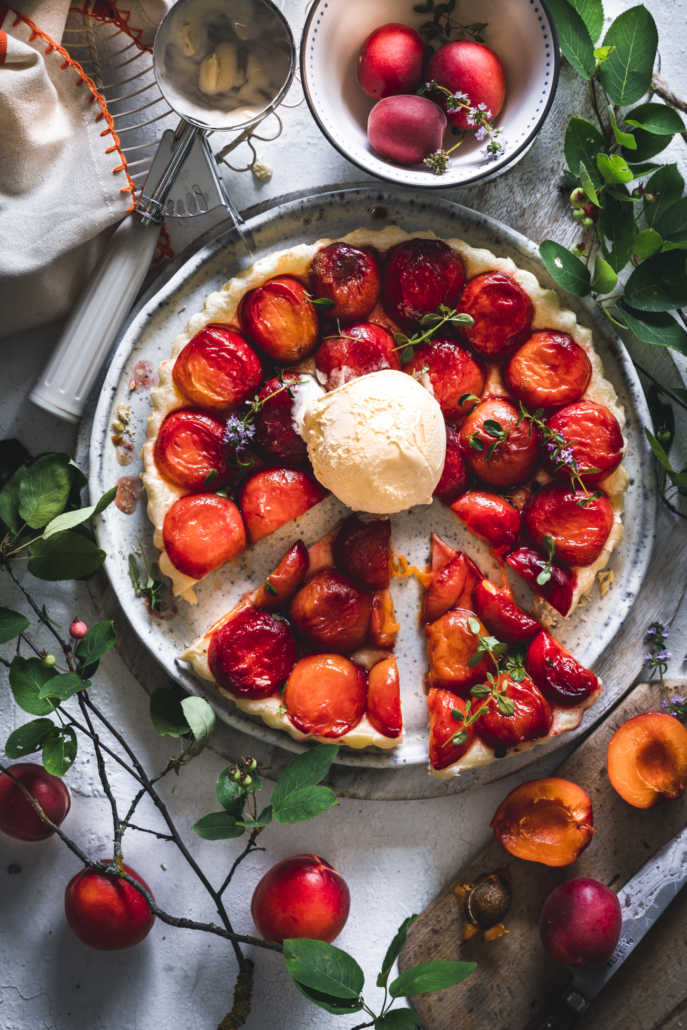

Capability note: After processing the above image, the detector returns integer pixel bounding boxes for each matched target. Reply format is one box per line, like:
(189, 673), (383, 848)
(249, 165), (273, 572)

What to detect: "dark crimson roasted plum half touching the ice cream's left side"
(251, 372), (309, 466)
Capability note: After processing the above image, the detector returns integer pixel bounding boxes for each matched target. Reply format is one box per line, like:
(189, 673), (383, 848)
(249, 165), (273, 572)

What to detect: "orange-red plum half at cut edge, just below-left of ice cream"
(239, 469), (327, 544)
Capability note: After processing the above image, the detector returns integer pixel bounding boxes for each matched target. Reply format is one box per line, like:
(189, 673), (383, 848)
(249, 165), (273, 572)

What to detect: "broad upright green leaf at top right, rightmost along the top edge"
(598, 4), (658, 107)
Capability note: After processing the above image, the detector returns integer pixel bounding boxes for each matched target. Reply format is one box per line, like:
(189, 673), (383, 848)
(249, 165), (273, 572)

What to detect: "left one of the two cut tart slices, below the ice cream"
(180, 515), (403, 748)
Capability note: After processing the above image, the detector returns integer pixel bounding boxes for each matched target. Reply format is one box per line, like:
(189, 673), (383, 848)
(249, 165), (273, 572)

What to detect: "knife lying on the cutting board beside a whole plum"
(526, 826), (687, 1030)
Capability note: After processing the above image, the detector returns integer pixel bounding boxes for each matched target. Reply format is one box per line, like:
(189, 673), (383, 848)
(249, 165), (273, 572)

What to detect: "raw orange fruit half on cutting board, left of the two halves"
(489, 777), (594, 866)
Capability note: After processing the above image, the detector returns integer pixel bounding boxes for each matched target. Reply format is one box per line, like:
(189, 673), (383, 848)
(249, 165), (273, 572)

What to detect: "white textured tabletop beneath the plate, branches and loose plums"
(0, 0), (687, 1030)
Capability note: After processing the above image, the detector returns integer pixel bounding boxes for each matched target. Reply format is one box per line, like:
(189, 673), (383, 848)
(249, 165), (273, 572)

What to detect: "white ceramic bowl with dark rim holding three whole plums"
(301, 0), (560, 190)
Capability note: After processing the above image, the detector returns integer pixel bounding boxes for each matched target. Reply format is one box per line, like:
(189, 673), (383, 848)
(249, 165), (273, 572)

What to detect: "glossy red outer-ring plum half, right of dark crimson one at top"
(458, 272), (535, 362)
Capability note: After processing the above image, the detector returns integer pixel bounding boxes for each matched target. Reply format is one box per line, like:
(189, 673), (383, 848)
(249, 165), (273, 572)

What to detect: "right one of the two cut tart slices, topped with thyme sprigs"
(421, 535), (602, 779)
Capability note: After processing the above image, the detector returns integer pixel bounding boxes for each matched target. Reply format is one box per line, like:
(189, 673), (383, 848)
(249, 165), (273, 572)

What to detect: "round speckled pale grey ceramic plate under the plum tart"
(90, 186), (656, 775)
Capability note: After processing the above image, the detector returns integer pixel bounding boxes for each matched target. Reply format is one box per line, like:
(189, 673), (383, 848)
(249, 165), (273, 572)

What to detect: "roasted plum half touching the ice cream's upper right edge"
(403, 336), (486, 422)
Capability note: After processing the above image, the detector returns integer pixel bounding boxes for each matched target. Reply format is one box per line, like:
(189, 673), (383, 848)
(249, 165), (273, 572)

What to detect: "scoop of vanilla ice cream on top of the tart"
(303, 369), (446, 515)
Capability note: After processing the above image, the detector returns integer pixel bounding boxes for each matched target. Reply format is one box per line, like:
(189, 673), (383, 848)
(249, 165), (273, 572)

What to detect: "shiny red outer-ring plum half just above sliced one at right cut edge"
(522, 483), (614, 567)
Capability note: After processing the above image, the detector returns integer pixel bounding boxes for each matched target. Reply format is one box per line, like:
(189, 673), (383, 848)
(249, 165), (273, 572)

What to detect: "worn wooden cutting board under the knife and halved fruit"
(399, 682), (687, 1030)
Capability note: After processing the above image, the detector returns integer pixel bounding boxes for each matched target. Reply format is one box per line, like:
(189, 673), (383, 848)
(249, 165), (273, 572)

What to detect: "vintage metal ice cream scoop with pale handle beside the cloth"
(30, 0), (296, 422)
